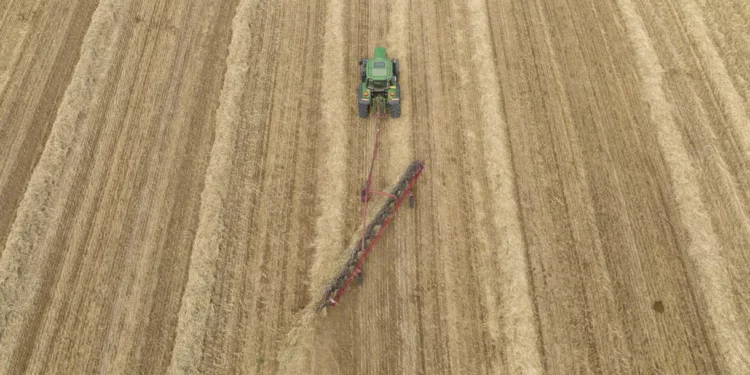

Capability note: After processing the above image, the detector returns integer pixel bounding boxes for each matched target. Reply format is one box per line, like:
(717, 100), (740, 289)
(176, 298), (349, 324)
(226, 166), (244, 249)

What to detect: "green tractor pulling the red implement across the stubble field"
(357, 47), (401, 118)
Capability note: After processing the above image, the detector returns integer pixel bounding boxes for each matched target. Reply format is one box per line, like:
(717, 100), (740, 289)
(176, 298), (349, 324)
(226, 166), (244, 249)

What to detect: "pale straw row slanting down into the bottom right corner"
(617, 0), (750, 374)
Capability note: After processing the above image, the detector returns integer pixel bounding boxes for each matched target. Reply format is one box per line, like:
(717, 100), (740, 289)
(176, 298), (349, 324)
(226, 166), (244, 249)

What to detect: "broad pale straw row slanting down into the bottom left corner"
(0, 0), (130, 373)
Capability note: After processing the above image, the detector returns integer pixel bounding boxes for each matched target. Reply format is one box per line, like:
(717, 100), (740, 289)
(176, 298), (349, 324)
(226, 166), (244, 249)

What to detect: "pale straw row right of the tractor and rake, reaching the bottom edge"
(468, 0), (542, 373)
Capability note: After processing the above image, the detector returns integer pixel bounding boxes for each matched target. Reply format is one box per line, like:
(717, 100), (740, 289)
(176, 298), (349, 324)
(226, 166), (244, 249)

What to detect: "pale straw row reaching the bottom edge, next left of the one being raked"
(168, 0), (257, 374)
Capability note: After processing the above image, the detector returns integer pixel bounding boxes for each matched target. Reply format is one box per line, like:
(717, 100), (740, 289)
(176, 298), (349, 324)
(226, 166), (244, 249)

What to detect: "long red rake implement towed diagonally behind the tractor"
(318, 128), (424, 311)
